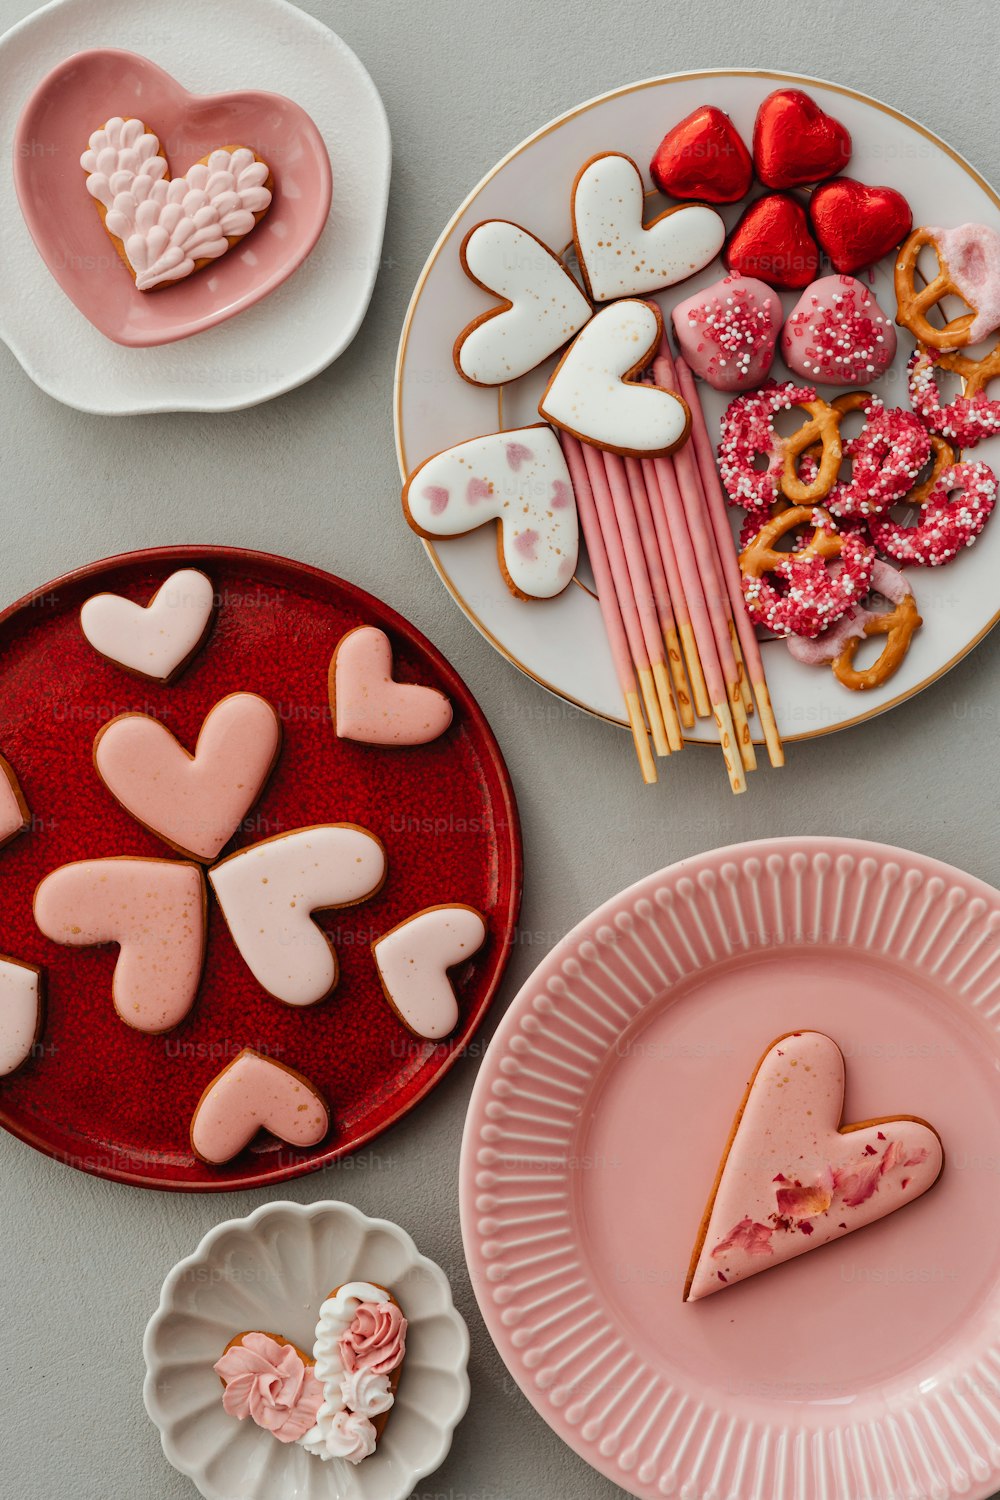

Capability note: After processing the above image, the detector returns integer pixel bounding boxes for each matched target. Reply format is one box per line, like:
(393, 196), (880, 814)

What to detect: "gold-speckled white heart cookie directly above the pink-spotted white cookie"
(454, 219), (594, 386)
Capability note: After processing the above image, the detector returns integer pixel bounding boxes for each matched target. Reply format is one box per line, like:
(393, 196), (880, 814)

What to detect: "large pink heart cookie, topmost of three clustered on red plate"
(94, 693), (282, 863)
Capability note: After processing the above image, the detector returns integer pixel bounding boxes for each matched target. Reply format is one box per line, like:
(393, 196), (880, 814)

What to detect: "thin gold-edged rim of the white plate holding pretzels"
(393, 68), (1000, 744)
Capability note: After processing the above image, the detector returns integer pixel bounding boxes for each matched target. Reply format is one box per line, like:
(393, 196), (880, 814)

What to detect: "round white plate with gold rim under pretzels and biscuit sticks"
(396, 69), (1000, 740)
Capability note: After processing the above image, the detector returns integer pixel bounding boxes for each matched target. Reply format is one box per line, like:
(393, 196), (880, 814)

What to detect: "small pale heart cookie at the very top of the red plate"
(79, 569), (214, 683)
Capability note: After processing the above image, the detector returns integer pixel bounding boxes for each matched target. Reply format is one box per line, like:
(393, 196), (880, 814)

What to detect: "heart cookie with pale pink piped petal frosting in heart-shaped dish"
(79, 116), (271, 291)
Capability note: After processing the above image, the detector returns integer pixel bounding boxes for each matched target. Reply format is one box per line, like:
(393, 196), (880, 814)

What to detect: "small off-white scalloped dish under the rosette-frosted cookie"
(142, 1203), (469, 1500)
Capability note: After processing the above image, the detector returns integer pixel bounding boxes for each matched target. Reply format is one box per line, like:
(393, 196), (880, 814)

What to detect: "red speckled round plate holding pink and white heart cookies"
(0, 546), (522, 1193)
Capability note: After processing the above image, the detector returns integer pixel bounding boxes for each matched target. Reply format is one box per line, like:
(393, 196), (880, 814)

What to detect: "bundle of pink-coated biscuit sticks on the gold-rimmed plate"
(559, 318), (784, 792)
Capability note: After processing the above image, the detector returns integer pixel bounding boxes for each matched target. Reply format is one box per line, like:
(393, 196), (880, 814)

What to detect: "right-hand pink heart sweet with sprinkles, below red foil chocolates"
(781, 276), (897, 386)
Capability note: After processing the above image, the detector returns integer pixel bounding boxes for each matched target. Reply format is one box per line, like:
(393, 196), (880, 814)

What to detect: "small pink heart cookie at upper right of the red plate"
(330, 626), (451, 746)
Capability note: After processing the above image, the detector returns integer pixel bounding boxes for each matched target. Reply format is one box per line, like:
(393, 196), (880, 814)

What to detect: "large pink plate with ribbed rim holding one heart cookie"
(462, 839), (1000, 1500)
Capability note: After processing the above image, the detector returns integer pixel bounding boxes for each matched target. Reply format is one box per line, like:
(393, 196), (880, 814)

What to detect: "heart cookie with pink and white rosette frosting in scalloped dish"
(213, 1281), (406, 1464)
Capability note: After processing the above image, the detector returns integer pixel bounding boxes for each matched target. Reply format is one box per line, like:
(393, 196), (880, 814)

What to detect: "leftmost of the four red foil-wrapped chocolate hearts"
(649, 104), (754, 203)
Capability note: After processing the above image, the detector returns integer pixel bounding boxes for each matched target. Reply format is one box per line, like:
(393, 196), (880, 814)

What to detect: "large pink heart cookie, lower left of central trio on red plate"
(34, 858), (205, 1032)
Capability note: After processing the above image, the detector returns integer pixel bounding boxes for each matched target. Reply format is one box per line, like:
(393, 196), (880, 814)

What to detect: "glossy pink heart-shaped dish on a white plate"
(13, 48), (333, 348)
